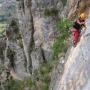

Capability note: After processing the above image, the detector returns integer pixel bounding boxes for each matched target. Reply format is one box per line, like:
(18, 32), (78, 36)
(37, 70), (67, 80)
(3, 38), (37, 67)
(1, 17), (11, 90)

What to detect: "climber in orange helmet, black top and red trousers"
(71, 13), (86, 46)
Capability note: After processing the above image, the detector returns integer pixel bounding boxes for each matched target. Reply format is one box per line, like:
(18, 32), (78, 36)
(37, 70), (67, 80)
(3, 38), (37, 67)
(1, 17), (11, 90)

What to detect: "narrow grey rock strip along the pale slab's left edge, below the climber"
(49, 47), (72, 90)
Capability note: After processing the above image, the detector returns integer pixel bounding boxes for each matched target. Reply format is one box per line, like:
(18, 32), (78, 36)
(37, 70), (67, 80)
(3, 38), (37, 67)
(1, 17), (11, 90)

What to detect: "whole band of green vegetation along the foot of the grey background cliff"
(5, 63), (53, 90)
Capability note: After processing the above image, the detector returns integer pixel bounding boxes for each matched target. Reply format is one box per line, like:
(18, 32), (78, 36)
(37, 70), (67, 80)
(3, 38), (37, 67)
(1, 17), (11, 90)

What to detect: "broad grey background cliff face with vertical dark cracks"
(0, 0), (63, 83)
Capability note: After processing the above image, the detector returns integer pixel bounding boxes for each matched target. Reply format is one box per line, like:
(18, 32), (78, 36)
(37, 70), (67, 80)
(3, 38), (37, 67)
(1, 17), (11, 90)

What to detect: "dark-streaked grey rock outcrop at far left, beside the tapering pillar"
(0, 19), (30, 90)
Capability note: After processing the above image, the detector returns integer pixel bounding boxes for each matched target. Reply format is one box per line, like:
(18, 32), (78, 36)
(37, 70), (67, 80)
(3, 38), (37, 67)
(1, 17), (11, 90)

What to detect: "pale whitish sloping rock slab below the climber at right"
(51, 18), (90, 90)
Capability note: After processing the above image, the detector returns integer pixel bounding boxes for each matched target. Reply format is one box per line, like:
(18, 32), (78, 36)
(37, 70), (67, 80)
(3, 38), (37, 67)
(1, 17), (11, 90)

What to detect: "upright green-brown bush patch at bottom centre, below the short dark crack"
(32, 62), (53, 90)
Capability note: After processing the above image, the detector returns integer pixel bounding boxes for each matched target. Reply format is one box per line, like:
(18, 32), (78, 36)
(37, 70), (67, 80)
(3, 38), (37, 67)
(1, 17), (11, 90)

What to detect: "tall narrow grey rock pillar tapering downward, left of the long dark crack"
(17, 0), (34, 72)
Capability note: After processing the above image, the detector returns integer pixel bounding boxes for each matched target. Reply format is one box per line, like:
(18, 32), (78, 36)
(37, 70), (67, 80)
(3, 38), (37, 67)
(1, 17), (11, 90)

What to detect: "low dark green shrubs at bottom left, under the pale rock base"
(5, 78), (35, 90)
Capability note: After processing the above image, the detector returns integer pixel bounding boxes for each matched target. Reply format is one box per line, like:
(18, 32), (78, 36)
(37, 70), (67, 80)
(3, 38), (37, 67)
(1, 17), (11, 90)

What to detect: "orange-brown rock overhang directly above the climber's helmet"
(61, 0), (90, 20)
